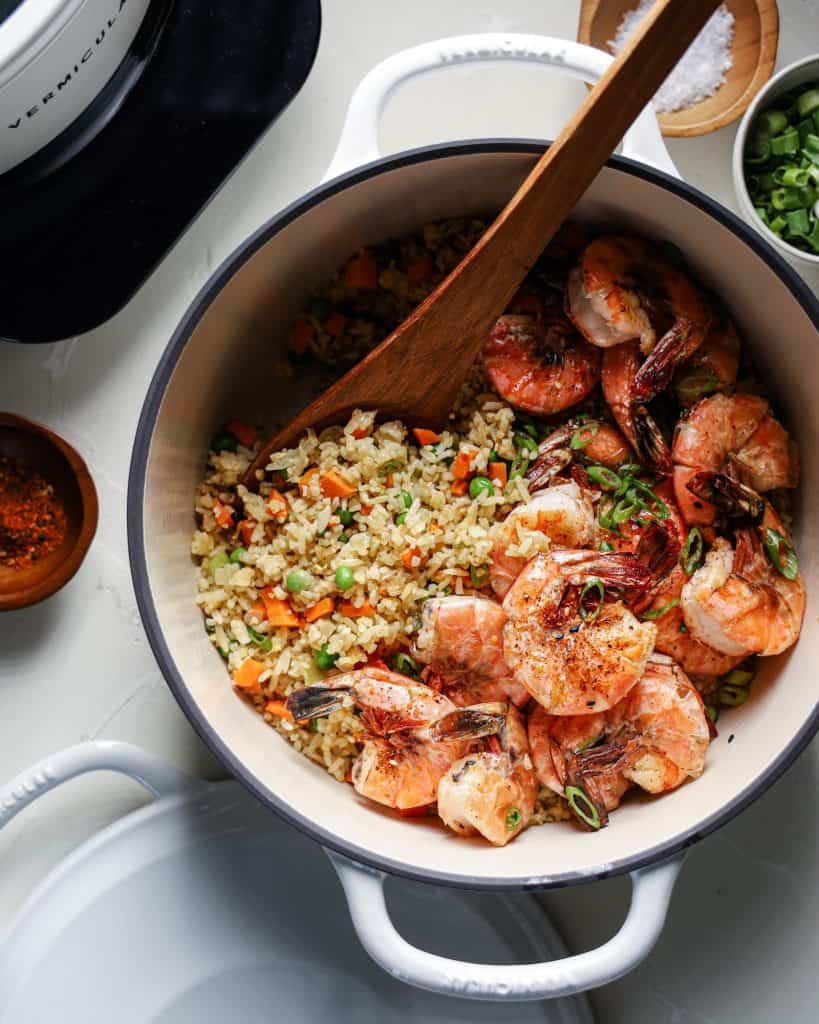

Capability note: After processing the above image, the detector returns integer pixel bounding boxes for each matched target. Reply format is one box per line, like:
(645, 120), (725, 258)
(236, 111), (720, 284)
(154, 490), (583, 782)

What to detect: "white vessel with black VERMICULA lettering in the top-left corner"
(0, 0), (169, 174)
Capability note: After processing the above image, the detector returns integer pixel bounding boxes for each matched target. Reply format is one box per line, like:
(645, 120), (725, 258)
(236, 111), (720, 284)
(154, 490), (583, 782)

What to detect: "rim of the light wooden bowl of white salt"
(577, 0), (779, 138)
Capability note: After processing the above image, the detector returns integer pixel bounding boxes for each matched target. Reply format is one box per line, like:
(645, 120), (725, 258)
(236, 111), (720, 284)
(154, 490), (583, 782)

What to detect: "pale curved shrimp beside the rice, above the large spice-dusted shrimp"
(489, 480), (597, 597)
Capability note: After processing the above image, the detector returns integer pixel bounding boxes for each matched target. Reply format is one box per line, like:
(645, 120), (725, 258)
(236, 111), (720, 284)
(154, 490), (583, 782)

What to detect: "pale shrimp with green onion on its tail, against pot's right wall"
(681, 502), (805, 657)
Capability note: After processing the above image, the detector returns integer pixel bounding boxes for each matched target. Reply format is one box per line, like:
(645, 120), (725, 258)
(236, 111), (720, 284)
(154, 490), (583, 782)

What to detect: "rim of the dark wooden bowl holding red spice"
(0, 413), (99, 611)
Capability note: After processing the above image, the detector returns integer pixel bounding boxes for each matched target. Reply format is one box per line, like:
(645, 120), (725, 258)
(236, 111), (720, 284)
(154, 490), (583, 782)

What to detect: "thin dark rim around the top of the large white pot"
(126, 138), (819, 892)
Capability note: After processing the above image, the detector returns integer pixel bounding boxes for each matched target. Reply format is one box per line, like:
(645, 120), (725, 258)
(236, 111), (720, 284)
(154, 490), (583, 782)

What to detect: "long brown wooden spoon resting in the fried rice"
(245, 0), (720, 486)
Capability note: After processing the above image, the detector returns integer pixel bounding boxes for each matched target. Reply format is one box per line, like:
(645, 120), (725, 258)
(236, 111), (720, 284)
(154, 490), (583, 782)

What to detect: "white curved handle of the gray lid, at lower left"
(0, 740), (205, 828)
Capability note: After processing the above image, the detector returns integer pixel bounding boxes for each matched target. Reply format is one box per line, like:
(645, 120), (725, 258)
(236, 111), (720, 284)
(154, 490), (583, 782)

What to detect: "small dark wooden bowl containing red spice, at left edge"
(0, 413), (98, 611)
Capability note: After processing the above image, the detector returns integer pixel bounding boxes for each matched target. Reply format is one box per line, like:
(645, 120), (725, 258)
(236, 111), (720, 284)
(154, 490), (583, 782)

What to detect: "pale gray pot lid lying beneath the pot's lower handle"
(0, 782), (593, 1024)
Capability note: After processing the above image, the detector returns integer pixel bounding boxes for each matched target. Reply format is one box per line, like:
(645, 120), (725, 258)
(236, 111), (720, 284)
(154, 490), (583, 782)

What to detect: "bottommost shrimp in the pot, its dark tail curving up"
(438, 705), (537, 846)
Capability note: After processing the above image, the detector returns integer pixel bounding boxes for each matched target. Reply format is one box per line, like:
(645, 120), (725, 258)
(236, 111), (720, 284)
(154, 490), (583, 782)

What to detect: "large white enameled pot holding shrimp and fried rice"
(128, 35), (819, 999)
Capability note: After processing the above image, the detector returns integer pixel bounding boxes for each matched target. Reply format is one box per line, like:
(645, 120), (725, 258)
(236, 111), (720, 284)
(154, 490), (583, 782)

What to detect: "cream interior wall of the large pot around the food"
(131, 147), (819, 884)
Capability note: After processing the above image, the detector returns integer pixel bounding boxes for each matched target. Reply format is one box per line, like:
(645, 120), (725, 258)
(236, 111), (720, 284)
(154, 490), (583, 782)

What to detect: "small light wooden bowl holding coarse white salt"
(577, 0), (779, 136)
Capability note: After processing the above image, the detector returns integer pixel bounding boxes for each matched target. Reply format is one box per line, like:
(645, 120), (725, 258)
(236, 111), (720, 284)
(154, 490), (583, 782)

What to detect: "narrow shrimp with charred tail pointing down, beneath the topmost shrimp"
(601, 341), (672, 474)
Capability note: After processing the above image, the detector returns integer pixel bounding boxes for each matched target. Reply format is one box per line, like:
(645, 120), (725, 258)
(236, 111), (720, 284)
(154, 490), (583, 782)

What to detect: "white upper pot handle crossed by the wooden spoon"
(324, 33), (680, 181)
